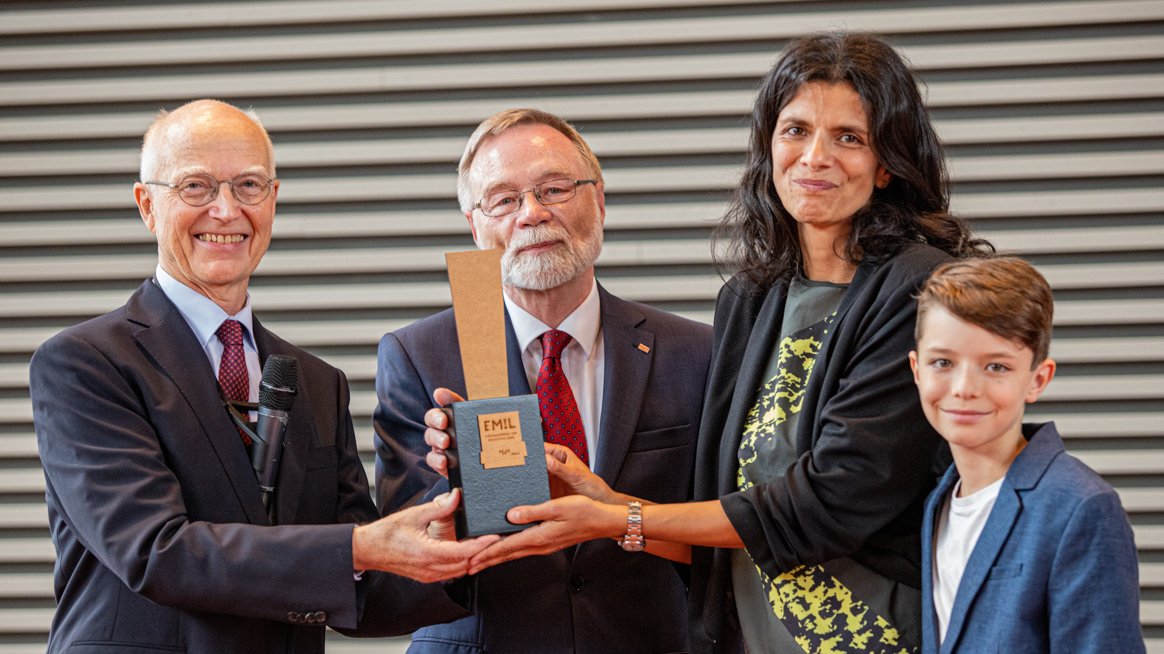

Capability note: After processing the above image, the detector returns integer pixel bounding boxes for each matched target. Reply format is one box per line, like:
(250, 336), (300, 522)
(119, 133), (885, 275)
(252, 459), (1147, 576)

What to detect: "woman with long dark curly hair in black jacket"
(463, 34), (992, 653)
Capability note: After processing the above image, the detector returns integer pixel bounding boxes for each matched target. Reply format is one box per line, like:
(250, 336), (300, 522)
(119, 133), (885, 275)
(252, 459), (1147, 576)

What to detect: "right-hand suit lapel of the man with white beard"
(595, 285), (661, 485)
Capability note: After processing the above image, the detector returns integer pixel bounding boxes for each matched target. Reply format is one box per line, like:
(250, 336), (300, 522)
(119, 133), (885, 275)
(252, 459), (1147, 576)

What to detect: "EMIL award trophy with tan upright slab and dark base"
(445, 250), (549, 539)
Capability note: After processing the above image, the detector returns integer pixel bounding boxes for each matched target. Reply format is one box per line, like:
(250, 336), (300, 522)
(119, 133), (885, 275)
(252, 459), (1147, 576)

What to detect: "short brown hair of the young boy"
(914, 256), (1055, 369)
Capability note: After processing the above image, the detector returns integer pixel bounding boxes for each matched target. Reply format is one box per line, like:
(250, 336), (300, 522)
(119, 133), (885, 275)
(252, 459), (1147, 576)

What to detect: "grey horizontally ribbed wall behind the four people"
(0, 0), (1164, 654)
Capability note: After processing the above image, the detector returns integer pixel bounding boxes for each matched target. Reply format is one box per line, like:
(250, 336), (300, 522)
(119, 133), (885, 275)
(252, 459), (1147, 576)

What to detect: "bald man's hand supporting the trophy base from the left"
(352, 489), (501, 583)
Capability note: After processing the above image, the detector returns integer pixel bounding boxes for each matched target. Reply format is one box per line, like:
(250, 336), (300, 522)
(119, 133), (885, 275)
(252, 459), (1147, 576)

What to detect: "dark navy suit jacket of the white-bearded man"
(375, 286), (711, 654)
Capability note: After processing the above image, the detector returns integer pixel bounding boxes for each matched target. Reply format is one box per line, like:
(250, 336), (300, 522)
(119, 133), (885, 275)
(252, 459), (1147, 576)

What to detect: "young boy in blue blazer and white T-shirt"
(909, 257), (1144, 654)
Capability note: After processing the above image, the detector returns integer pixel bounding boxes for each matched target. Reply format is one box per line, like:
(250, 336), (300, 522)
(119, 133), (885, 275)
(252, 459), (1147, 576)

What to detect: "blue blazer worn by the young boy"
(922, 422), (1144, 654)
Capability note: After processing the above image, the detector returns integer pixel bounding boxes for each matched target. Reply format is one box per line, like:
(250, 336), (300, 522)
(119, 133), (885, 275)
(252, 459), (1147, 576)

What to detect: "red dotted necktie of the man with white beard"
(538, 329), (590, 465)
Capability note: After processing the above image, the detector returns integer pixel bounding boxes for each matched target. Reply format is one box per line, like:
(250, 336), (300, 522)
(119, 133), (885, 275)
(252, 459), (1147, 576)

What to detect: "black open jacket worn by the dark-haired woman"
(690, 244), (950, 652)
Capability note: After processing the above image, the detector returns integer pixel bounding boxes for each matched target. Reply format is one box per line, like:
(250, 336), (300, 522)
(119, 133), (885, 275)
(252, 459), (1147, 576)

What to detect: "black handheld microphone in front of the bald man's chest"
(250, 354), (299, 510)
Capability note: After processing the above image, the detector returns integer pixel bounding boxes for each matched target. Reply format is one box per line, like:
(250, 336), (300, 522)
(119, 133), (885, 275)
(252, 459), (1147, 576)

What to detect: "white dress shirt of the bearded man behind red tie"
(504, 276), (606, 469)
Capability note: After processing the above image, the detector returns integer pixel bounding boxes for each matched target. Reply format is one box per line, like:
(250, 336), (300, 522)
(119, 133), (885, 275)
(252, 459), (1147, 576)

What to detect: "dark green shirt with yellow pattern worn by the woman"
(732, 277), (908, 653)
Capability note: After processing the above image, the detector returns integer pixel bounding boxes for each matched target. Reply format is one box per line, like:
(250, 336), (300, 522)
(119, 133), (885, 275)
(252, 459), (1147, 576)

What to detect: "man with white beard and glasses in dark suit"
(374, 109), (711, 654)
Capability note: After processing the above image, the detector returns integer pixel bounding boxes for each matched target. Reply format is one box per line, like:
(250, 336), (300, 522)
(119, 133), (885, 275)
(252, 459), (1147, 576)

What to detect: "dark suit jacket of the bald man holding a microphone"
(30, 280), (458, 653)
